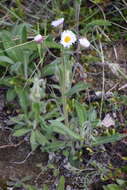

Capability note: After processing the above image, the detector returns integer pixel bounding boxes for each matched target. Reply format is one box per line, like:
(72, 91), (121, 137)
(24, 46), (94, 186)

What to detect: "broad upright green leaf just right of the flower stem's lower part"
(75, 102), (87, 126)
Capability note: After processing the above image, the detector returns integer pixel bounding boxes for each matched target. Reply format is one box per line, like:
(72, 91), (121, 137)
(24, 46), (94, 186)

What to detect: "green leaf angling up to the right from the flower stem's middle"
(65, 82), (90, 96)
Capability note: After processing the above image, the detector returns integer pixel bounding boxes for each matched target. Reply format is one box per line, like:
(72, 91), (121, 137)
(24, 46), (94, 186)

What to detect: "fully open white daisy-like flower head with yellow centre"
(60, 30), (76, 48)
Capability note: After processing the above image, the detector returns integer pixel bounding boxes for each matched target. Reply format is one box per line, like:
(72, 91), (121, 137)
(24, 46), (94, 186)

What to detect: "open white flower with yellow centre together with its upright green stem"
(59, 30), (77, 127)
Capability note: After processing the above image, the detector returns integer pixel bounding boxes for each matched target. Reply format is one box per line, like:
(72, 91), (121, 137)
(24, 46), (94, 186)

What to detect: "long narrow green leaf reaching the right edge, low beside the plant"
(92, 133), (127, 146)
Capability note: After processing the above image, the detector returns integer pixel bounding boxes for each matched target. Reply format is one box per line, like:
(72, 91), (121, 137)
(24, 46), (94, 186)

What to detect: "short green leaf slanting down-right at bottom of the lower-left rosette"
(35, 130), (49, 146)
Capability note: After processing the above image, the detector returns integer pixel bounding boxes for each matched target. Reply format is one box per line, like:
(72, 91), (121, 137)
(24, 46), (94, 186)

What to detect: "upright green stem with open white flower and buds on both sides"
(51, 18), (90, 127)
